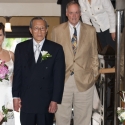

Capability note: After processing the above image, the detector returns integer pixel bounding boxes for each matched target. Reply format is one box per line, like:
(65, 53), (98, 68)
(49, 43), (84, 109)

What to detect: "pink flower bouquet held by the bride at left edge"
(0, 61), (9, 82)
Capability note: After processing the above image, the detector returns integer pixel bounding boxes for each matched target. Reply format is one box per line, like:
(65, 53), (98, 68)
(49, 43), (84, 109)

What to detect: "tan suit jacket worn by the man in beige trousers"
(52, 22), (98, 92)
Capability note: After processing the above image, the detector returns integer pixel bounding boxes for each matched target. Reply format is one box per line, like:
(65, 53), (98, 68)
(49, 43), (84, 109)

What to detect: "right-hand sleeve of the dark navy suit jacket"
(52, 46), (65, 104)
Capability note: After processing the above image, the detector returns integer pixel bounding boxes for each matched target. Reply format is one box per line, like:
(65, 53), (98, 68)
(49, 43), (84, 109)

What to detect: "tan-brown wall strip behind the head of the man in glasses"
(0, 16), (60, 39)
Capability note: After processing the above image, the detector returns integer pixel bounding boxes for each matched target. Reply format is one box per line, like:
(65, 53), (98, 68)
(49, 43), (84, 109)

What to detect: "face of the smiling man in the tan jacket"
(66, 4), (81, 26)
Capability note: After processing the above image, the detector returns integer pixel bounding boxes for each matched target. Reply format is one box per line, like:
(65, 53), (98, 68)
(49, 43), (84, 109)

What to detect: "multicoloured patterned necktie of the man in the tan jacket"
(71, 27), (77, 55)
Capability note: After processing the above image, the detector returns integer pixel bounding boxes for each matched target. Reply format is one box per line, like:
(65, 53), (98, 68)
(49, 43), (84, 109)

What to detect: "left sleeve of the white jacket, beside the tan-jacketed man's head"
(79, 0), (92, 25)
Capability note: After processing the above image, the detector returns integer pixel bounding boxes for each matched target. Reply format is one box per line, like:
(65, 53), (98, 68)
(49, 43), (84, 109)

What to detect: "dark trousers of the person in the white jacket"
(97, 30), (116, 50)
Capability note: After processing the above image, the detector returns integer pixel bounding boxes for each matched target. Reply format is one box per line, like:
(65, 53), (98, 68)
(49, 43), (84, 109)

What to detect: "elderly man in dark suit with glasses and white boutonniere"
(12, 17), (65, 125)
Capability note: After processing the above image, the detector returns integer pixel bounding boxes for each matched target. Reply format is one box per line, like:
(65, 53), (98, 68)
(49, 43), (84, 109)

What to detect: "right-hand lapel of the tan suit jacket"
(75, 22), (87, 59)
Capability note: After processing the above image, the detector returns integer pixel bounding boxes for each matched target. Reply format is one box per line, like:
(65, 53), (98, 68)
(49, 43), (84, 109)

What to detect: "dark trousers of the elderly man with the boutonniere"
(20, 111), (54, 125)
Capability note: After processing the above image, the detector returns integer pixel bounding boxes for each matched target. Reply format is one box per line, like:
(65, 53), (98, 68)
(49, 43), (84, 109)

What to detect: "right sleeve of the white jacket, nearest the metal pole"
(102, 0), (116, 33)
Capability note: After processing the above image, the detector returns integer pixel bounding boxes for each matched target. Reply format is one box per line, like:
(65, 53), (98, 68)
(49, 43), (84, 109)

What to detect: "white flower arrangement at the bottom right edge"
(117, 91), (125, 123)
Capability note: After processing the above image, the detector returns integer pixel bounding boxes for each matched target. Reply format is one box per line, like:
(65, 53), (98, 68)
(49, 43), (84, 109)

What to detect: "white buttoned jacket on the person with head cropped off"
(79, 0), (116, 33)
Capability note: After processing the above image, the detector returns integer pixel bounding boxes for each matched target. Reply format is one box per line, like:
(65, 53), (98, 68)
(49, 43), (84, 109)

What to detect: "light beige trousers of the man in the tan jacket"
(56, 75), (95, 125)
